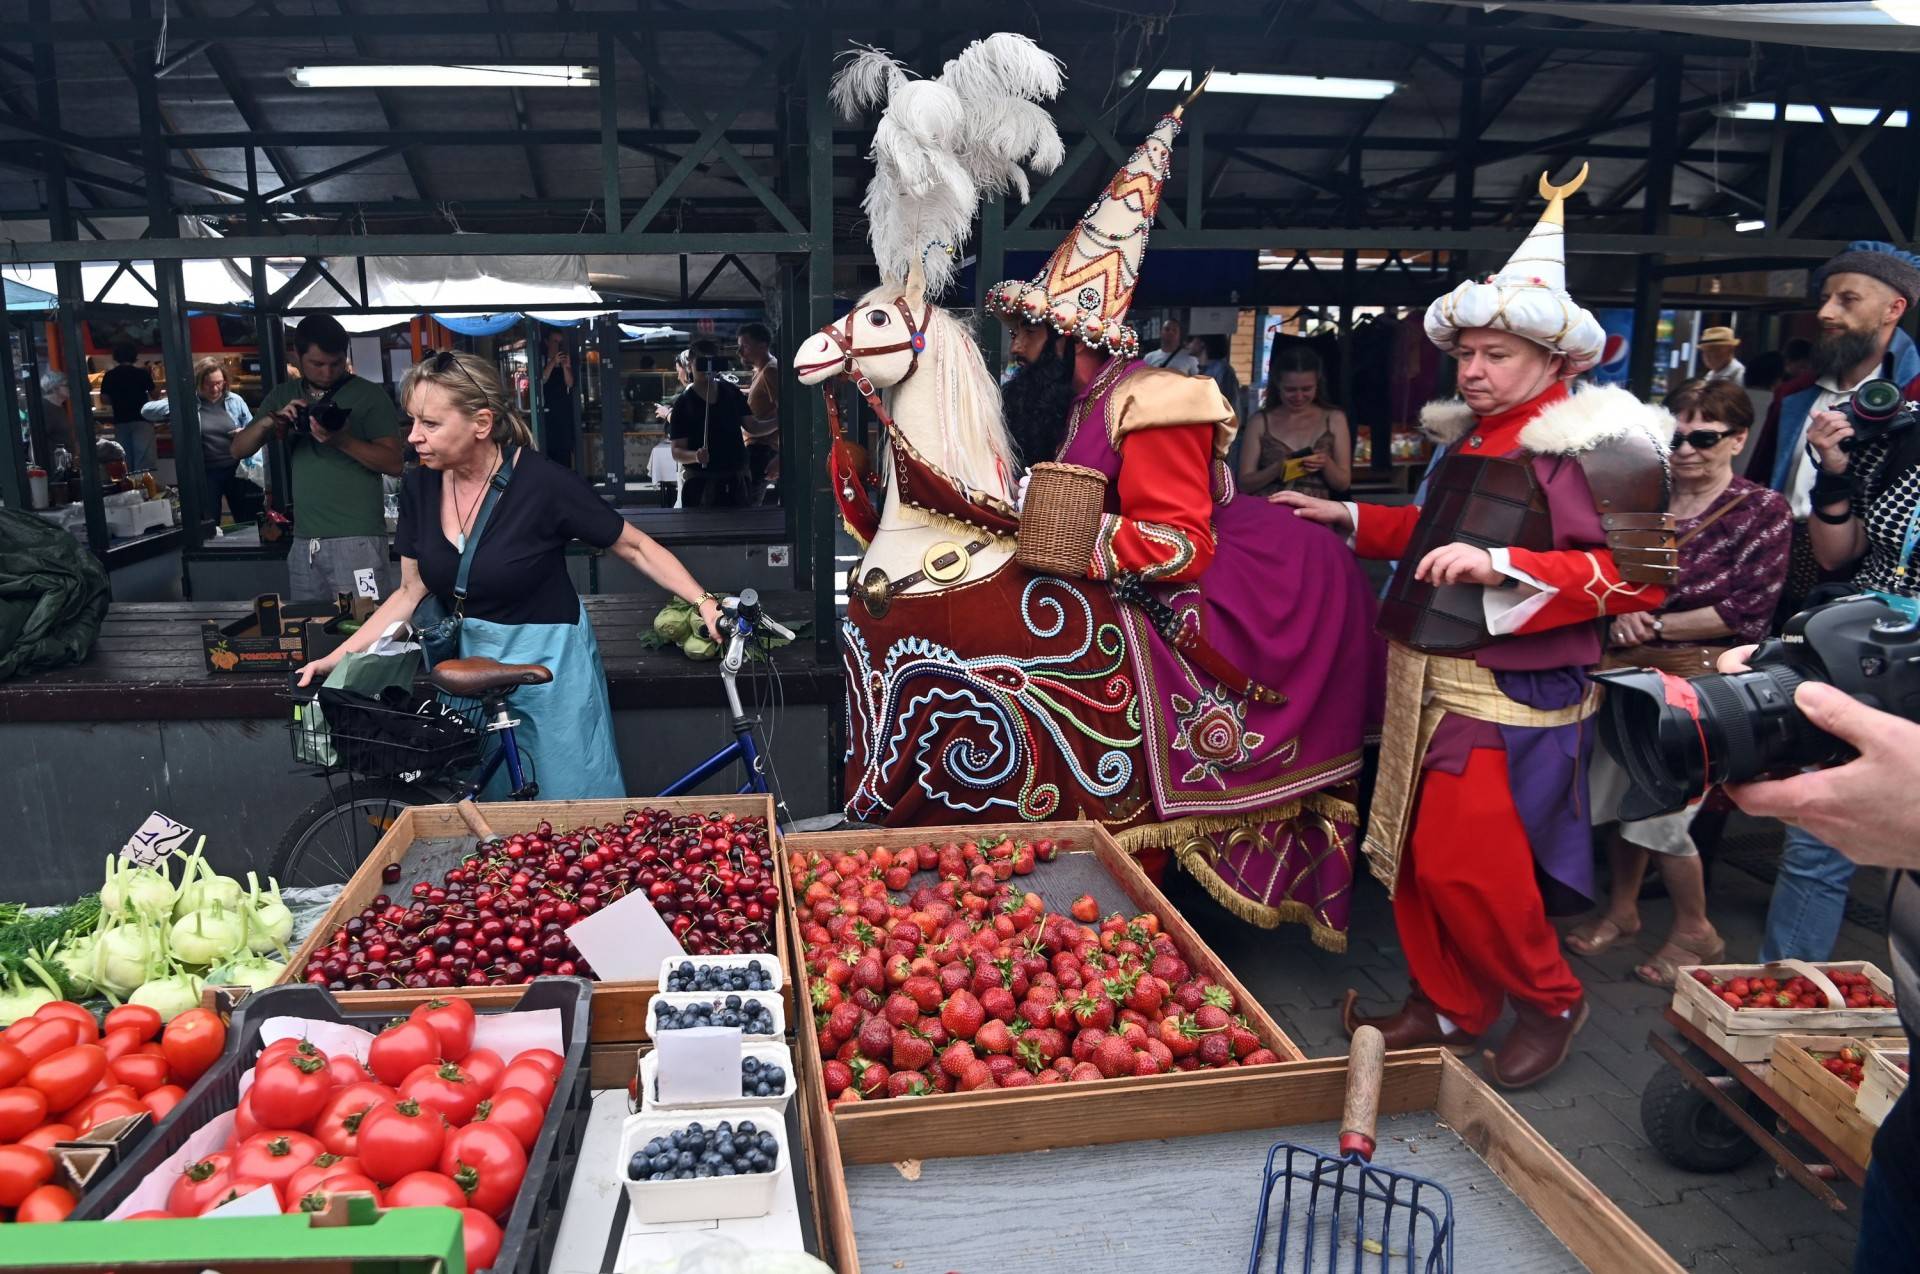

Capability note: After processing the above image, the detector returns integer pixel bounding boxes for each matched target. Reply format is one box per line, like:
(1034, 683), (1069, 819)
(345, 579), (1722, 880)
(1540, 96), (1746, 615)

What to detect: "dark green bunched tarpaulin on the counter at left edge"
(0, 508), (111, 681)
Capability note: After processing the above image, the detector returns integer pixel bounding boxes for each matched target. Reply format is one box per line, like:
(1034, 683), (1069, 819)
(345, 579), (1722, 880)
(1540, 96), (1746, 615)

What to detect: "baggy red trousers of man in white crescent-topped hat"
(1394, 748), (1582, 1034)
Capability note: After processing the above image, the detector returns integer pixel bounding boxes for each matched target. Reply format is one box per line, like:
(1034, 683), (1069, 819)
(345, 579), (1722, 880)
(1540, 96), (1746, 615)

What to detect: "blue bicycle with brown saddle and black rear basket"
(273, 589), (793, 886)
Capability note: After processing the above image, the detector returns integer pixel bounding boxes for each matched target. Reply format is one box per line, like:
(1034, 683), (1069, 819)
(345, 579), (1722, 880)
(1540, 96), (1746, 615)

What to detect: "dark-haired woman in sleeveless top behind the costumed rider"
(1240, 345), (1354, 499)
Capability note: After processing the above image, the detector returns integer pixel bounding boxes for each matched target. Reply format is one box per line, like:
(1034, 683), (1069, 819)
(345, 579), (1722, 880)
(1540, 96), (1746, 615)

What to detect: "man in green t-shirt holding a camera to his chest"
(232, 315), (403, 601)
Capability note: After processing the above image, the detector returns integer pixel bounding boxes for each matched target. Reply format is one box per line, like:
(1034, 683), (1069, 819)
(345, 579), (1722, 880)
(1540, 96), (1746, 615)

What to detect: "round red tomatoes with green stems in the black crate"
(129, 1000), (564, 1270)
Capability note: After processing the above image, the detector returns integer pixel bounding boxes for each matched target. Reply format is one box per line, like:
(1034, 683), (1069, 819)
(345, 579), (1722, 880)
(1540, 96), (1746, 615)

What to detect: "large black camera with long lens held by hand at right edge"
(1594, 595), (1920, 819)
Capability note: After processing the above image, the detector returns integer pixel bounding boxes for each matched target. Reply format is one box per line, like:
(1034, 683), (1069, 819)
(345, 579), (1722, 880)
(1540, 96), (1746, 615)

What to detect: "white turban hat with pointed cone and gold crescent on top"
(1427, 165), (1607, 376)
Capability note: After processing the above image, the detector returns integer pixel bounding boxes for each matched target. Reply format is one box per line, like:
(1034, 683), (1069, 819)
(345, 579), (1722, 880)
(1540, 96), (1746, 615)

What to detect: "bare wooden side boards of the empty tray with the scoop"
(810, 1050), (1680, 1274)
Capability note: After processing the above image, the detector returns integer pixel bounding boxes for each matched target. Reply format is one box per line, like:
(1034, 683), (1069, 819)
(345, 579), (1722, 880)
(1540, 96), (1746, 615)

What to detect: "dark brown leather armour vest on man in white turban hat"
(1379, 453), (1553, 654)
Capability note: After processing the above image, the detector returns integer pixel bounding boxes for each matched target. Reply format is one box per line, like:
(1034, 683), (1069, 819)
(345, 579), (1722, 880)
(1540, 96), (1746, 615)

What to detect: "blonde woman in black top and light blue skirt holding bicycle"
(301, 353), (720, 800)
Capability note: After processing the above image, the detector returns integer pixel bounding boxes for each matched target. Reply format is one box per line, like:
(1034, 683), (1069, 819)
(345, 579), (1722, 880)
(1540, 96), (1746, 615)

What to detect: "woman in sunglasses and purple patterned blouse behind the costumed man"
(1567, 380), (1791, 986)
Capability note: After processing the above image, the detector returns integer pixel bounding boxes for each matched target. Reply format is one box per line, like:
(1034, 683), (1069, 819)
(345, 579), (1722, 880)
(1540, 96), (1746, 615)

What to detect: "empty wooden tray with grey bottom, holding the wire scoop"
(812, 1050), (1680, 1274)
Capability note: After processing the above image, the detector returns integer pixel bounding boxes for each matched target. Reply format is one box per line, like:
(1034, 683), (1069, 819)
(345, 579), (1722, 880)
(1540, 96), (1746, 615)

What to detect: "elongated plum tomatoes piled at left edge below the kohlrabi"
(0, 1000), (227, 1220)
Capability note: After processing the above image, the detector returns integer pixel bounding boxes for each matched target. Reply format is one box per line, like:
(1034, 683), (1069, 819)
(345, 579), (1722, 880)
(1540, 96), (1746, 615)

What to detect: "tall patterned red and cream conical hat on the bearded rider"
(985, 104), (1185, 359)
